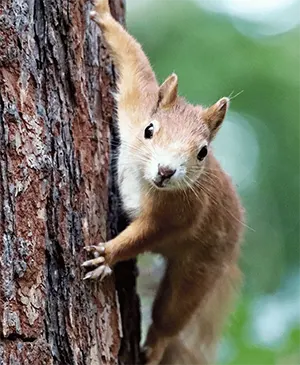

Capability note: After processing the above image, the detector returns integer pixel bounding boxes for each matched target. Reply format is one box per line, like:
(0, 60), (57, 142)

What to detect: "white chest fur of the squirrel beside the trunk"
(118, 145), (142, 219)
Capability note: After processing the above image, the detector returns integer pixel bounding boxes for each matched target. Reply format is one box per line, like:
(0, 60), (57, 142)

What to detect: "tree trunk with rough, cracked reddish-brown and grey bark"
(0, 0), (140, 365)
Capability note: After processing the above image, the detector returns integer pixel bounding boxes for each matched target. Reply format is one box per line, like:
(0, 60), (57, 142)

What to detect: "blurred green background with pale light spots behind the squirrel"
(127, 0), (300, 365)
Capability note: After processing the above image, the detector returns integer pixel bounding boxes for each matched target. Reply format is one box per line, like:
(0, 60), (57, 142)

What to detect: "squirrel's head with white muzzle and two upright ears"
(132, 74), (229, 189)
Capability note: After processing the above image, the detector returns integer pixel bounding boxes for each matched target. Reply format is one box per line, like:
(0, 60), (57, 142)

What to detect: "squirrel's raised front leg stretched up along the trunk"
(91, 0), (158, 125)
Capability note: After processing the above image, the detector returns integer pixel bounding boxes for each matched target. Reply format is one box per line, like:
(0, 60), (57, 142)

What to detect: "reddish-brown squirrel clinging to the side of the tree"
(82, 0), (244, 365)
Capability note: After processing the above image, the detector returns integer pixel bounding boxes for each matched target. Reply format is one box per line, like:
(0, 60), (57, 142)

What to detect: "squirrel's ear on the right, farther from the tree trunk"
(203, 98), (229, 138)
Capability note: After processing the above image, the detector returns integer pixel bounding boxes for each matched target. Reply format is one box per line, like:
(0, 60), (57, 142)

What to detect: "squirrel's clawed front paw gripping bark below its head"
(81, 243), (112, 280)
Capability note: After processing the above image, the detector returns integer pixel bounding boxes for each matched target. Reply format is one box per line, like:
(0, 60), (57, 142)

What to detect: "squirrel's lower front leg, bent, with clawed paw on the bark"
(82, 218), (163, 279)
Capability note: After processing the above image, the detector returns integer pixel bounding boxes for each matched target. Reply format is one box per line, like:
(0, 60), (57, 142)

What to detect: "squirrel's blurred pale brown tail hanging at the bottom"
(160, 266), (241, 365)
